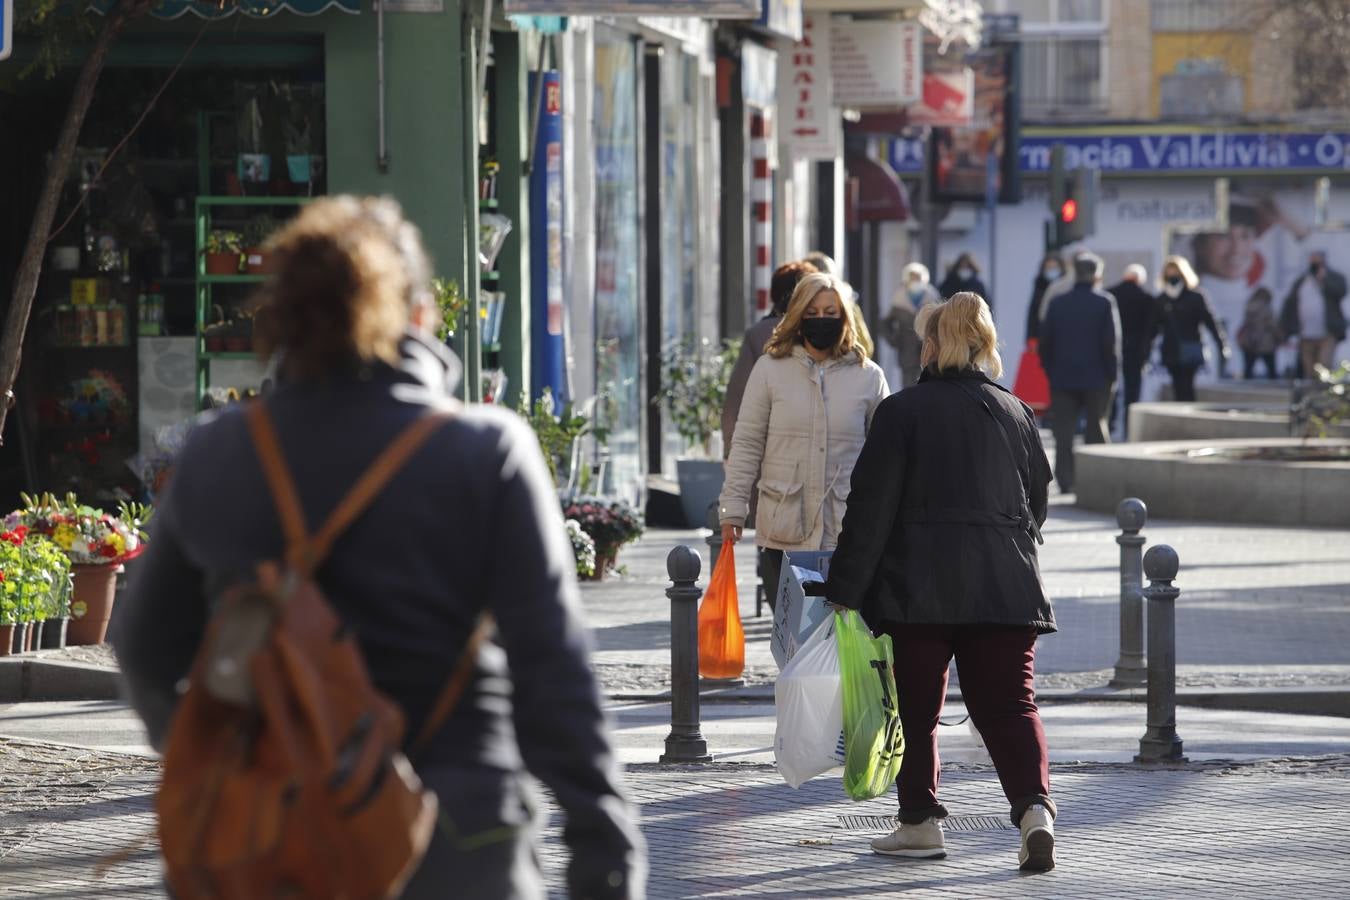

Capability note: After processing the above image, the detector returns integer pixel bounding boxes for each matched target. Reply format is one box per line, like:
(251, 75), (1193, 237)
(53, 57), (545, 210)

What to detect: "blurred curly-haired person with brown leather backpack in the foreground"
(113, 197), (645, 900)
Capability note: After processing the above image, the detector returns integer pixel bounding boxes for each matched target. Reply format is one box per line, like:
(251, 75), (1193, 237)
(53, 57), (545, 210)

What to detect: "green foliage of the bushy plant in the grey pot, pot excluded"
(660, 339), (741, 457)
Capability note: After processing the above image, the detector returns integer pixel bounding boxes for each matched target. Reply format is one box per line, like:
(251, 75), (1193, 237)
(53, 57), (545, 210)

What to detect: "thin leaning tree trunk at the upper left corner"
(0, 0), (150, 443)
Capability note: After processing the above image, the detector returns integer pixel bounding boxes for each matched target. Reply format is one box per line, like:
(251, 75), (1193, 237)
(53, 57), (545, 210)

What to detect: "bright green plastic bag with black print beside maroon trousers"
(834, 610), (905, 800)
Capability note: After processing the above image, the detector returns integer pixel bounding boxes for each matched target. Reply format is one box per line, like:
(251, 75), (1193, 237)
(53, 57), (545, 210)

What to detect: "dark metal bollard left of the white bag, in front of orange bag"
(660, 544), (713, 764)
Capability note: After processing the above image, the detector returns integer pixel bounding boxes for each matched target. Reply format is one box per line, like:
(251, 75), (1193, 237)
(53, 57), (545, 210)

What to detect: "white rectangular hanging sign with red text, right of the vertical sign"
(830, 20), (923, 109)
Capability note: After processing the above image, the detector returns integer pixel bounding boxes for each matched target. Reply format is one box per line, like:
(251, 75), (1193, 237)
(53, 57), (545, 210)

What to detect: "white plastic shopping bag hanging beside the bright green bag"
(774, 615), (845, 788)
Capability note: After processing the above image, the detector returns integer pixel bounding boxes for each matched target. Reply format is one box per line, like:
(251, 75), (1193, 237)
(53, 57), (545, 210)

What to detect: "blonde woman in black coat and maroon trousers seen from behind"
(824, 293), (1056, 870)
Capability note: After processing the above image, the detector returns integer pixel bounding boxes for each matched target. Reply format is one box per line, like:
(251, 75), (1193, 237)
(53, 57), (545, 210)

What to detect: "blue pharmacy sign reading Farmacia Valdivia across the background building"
(887, 131), (1350, 175)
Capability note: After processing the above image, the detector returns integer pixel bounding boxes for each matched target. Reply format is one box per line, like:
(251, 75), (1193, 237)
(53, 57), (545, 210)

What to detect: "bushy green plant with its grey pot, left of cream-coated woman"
(660, 339), (741, 528)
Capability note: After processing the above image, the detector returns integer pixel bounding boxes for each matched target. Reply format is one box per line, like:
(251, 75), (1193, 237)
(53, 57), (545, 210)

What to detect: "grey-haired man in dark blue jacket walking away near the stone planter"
(1041, 251), (1121, 494)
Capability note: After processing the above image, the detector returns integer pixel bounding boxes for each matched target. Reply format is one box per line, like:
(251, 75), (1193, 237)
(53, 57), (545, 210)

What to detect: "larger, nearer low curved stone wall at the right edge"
(1075, 439), (1350, 528)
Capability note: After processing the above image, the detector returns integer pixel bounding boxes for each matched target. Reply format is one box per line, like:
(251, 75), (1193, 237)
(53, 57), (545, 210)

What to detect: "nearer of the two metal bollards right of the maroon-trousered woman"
(1134, 544), (1185, 762)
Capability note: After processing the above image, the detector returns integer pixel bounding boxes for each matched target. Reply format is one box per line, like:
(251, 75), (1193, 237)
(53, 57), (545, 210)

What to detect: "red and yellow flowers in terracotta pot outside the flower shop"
(4, 494), (153, 645)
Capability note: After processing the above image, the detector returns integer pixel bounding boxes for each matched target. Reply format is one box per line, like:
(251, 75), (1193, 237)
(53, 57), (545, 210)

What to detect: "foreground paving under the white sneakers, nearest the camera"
(0, 741), (1350, 900)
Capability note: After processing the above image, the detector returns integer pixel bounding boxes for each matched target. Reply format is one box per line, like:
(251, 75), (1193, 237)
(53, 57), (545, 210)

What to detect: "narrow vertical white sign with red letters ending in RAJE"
(778, 13), (840, 159)
